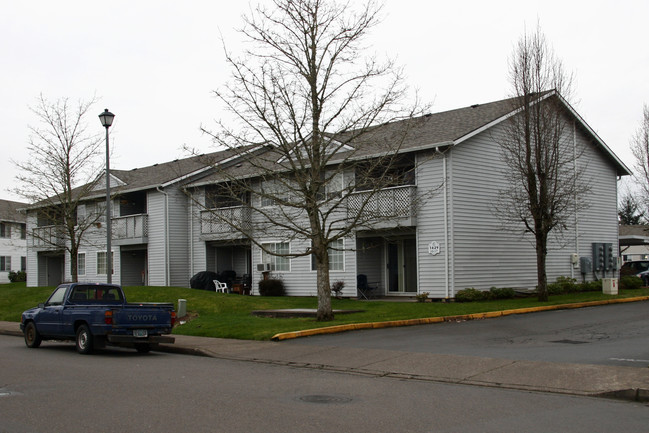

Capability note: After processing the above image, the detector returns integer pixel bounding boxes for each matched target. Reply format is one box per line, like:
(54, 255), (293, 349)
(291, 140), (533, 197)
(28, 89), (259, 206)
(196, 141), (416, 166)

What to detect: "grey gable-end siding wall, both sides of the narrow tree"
(450, 120), (617, 291)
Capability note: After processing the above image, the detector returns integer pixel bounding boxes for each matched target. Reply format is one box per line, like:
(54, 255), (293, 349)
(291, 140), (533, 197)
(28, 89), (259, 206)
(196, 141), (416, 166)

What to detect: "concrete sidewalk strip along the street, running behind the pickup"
(0, 322), (649, 401)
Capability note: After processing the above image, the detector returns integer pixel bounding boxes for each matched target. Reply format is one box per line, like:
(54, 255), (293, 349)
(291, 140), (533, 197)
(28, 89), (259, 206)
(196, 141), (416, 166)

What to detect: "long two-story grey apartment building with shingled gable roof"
(28, 92), (630, 298)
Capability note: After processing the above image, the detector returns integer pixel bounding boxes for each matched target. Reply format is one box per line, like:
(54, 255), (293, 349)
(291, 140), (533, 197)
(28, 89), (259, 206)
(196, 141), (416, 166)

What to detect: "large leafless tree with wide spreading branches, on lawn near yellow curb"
(201, 0), (426, 320)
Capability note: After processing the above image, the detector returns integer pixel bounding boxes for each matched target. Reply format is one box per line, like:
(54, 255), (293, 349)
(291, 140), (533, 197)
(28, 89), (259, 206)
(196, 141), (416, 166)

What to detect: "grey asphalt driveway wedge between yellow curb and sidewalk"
(283, 302), (649, 367)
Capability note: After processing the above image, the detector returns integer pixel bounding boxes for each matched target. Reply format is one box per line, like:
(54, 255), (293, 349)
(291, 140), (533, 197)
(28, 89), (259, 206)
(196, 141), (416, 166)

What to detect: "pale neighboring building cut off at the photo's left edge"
(0, 200), (27, 283)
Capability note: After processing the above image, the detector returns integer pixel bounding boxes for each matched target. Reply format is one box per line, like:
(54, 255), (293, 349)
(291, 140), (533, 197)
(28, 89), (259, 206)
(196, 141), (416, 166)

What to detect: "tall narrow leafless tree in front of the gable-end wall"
(498, 27), (588, 301)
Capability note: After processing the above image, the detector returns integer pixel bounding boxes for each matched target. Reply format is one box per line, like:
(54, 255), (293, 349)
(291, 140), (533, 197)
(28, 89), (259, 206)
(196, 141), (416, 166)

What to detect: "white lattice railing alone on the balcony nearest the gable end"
(347, 185), (417, 220)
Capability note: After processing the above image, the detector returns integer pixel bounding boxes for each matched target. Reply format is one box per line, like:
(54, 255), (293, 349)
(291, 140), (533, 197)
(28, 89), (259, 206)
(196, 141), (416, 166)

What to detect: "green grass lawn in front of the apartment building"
(5, 283), (649, 340)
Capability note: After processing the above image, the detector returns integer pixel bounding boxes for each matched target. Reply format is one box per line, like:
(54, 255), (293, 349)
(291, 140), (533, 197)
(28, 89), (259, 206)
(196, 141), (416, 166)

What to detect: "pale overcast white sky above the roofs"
(0, 0), (649, 200)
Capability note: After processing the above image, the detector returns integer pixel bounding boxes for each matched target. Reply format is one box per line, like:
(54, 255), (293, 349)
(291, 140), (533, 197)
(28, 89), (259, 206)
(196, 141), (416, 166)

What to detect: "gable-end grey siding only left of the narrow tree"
(449, 126), (548, 293)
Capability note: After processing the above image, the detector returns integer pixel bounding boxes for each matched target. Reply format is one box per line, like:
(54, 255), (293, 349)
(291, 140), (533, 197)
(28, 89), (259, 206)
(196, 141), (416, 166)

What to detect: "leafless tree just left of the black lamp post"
(15, 95), (103, 281)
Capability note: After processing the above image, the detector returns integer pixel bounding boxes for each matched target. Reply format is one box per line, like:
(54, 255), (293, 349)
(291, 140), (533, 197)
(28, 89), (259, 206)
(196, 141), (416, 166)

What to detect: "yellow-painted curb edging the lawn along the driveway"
(271, 296), (649, 341)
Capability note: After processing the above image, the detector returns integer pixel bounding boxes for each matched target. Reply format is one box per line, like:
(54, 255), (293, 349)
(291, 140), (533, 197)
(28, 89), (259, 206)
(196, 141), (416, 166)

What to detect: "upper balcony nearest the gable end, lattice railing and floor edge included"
(347, 185), (417, 228)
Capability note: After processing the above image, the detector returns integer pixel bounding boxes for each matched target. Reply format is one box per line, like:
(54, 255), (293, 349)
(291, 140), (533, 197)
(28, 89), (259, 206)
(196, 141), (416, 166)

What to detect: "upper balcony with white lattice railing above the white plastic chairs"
(201, 206), (251, 240)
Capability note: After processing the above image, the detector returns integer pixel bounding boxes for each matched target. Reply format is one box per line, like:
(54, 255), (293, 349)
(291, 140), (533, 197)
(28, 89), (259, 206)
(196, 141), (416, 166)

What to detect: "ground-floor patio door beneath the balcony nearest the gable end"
(386, 239), (417, 293)
